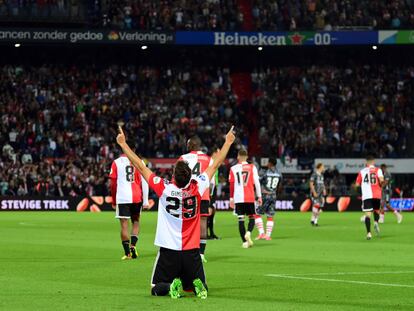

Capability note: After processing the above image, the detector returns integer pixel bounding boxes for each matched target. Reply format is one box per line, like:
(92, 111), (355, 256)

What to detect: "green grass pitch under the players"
(0, 212), (414, 311)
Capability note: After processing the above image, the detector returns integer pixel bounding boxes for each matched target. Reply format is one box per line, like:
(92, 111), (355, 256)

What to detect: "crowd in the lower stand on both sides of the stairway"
(0, 64), (414, 195)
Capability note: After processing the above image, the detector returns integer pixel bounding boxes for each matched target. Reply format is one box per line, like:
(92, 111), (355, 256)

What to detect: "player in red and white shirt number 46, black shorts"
(356, 156), (384, 240)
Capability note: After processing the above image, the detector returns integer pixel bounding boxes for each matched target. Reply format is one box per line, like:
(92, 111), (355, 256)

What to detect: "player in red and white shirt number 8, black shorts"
(109, 154), (148, 260)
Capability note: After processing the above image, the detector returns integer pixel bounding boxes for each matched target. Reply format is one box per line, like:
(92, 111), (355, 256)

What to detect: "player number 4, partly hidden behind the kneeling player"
(178, 136), (214, 263)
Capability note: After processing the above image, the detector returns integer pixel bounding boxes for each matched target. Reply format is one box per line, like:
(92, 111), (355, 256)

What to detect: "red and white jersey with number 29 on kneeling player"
(149, 174), (209, 250)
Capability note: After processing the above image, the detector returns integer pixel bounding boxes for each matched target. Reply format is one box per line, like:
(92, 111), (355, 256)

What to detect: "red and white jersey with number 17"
(229, 162), (262, 203)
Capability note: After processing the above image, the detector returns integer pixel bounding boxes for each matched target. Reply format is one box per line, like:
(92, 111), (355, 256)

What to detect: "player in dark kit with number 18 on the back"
(255, 158), (283, 240)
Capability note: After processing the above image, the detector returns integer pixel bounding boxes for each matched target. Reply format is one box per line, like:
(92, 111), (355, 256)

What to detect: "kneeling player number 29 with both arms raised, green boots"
(116, 127), (235, 298)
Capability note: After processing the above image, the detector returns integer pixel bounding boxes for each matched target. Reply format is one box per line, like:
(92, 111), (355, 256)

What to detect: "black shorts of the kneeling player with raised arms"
(151, 247), (206, 290)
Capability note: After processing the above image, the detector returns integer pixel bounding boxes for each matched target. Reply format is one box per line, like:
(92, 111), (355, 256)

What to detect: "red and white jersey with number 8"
(109, 154), (148, 205)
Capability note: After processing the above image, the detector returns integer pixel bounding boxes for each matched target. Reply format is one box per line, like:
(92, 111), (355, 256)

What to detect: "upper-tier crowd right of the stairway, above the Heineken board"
(252, 0), (414, 31)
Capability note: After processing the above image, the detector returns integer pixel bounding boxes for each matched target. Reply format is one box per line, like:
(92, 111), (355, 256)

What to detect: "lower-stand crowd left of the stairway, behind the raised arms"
(0, 66), (246, 195)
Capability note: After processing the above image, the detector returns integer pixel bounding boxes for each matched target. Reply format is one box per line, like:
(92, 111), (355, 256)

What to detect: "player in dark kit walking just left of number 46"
(309, 163), (326, 226)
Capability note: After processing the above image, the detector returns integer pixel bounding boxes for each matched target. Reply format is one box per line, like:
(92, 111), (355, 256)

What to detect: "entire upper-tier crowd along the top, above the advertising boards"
(0, 0), (414, 31)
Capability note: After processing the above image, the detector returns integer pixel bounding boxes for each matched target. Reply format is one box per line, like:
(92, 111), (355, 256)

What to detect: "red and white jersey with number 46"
(356, 165), (384, 200)
